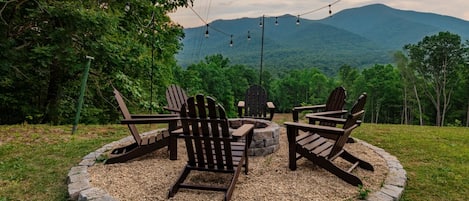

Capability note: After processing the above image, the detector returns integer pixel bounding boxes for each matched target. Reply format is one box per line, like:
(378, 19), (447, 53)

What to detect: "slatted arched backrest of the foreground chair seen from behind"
(180, 94), (233, 170)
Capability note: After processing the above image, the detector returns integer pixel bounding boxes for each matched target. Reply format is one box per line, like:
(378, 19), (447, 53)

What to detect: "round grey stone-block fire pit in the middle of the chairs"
(229, 118), (280, 156)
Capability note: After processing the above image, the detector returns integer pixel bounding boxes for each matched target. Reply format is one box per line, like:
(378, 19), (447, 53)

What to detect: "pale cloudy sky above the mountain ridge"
(170, 0), (469, 28)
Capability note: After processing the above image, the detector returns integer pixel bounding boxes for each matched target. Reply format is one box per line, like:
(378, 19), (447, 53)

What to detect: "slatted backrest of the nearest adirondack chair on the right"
(329, 110), (365, 157)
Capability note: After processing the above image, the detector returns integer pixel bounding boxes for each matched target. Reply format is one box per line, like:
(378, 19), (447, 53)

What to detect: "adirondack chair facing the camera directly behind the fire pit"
(238, 85), (275, 121)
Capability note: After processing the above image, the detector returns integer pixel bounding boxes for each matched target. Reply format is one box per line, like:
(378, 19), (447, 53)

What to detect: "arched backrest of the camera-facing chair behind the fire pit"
(244, 85), (267, 118)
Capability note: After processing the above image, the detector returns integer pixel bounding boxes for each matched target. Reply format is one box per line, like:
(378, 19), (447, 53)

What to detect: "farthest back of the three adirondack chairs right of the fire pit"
(292, 87), (347, 126)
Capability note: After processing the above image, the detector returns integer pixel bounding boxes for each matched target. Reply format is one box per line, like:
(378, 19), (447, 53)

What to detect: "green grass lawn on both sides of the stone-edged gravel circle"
(0, 114), (469, 201)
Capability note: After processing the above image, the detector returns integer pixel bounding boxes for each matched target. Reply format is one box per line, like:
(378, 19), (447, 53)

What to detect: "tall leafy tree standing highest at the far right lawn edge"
(404, 32), (464, 126)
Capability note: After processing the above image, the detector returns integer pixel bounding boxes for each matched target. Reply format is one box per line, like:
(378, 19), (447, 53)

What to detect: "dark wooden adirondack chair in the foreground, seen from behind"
(168, 95), (254, 200)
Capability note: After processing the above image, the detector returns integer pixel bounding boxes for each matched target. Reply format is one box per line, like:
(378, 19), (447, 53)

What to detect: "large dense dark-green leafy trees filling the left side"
(0, 0), (189, 124)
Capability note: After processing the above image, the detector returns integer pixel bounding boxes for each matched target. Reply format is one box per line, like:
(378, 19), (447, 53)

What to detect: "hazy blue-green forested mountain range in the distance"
(177, 4), (469, 75)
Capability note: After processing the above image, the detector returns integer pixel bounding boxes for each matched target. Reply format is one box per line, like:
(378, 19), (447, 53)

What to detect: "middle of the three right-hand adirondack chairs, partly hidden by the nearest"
(306, 92), (367, 143)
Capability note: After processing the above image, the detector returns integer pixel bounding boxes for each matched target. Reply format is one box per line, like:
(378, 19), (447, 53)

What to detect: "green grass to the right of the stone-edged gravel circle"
(352, 124), (469, 201)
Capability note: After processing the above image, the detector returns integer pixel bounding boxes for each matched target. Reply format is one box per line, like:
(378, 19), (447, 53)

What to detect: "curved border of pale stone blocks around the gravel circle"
(67, 130), (407, 201)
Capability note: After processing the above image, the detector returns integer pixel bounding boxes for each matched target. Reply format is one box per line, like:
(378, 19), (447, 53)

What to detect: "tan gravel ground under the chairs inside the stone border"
(88, 128), (388, 201)
